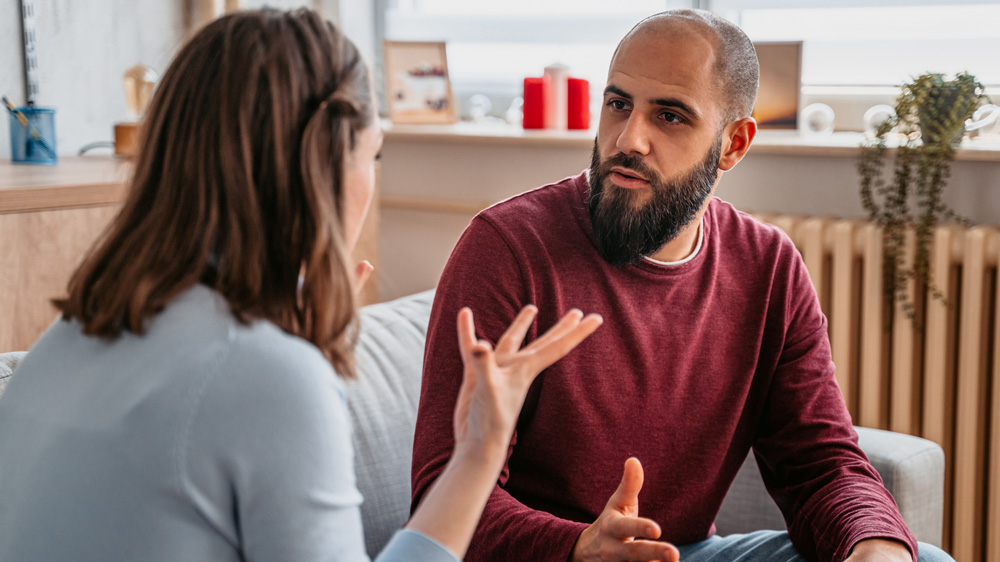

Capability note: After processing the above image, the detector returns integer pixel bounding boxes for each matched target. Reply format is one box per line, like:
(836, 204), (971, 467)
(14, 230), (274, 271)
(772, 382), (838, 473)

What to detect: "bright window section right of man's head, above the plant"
(728, 0), (1000, 86)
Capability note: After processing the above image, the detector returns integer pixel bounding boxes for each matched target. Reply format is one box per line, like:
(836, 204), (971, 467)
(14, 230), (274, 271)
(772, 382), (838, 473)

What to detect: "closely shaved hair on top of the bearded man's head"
(612, 10), (760, 123)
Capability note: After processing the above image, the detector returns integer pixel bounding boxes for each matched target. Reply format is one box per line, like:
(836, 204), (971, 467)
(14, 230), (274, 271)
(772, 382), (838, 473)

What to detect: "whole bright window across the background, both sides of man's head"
(377, 0), (1000, 126)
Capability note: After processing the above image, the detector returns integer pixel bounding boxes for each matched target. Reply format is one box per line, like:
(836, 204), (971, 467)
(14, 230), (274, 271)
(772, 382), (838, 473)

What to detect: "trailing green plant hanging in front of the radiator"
(858, 73), (986, 329)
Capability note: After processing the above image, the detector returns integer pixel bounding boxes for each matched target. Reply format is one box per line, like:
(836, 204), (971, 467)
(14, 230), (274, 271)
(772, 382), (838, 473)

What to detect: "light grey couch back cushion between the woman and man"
(347, 290), (434, 558)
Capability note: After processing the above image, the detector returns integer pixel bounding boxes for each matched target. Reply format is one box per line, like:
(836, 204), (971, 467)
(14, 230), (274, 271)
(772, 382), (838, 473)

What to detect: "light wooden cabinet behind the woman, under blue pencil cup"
(0, 157), (378, 352)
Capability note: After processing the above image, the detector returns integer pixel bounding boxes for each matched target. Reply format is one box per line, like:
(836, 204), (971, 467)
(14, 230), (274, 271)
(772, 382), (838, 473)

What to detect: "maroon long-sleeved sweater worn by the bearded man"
(413, 174), (916, 562)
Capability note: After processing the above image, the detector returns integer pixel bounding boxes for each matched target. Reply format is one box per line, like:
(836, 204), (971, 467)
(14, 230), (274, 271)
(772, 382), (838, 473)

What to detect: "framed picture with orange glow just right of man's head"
(753, 41), (802, 129)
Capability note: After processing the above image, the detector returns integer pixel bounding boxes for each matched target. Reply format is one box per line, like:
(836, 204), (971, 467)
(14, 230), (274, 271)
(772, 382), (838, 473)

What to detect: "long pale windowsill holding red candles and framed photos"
(382, 120), (1000, 162)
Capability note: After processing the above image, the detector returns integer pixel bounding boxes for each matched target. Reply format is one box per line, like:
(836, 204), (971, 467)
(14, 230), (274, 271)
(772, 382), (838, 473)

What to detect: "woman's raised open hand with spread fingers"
(455, 305), (603, 463)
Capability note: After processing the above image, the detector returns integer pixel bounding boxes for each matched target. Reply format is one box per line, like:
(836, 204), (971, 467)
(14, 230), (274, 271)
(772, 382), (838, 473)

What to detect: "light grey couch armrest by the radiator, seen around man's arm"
(715, 427), (944, 546)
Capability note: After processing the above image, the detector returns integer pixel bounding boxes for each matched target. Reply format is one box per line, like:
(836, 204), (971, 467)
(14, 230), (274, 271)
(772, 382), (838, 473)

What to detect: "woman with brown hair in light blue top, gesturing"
(0, 10), (601, 562)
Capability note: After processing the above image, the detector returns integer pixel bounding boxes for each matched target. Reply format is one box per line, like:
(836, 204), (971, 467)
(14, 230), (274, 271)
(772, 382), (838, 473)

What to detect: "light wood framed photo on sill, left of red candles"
(382, 41), (458, 123)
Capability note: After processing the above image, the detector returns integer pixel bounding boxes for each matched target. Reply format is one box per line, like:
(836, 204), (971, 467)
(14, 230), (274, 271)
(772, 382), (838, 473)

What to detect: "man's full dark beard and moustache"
(587, 136), (722, 267)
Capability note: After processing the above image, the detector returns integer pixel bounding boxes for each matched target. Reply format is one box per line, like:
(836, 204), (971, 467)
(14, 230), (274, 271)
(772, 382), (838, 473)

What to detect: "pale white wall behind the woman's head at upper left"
(0, 0), (374, 158)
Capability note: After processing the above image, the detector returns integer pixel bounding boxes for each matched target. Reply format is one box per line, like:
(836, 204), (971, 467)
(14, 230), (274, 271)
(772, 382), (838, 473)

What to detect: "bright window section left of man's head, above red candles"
(384, 0), (691, 114)
